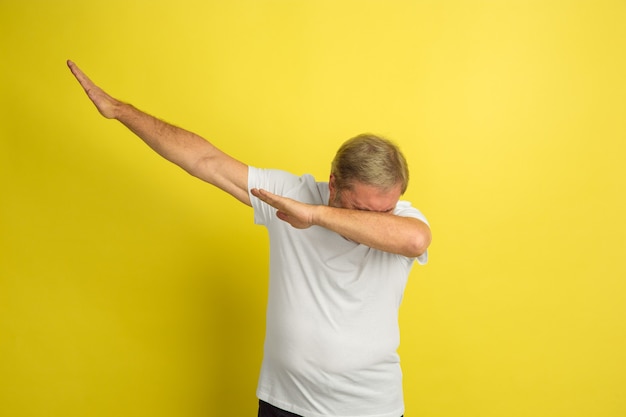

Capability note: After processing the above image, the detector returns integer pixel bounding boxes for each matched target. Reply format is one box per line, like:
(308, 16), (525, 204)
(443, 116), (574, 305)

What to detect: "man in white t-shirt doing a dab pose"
(68, 61), (431, 417)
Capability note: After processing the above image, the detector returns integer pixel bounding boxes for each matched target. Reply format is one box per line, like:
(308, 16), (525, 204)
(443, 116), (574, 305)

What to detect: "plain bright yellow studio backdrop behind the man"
(0, 0), (626, 417)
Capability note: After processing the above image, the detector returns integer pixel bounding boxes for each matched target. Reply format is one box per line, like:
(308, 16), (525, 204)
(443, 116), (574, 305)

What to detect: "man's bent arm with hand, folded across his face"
(251, 189), (432, 258)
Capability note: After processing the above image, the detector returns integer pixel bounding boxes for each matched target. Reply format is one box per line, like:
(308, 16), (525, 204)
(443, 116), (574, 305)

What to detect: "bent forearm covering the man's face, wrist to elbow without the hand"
(313, 206), (431, 257)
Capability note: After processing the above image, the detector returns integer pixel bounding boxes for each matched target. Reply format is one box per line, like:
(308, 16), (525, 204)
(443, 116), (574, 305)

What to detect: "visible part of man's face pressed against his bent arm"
(328, 175), (402, 213)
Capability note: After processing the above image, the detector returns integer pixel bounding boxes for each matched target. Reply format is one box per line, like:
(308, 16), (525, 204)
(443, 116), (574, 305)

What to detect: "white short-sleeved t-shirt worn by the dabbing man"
(248, 167), (427, 417)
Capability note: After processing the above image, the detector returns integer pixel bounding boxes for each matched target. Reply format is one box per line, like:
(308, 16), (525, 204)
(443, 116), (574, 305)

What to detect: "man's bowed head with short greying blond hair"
(329, 134), (409, 211)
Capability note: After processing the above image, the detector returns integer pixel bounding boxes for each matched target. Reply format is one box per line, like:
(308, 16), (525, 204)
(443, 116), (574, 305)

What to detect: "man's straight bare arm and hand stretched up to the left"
(67, 61), (250, 205)
